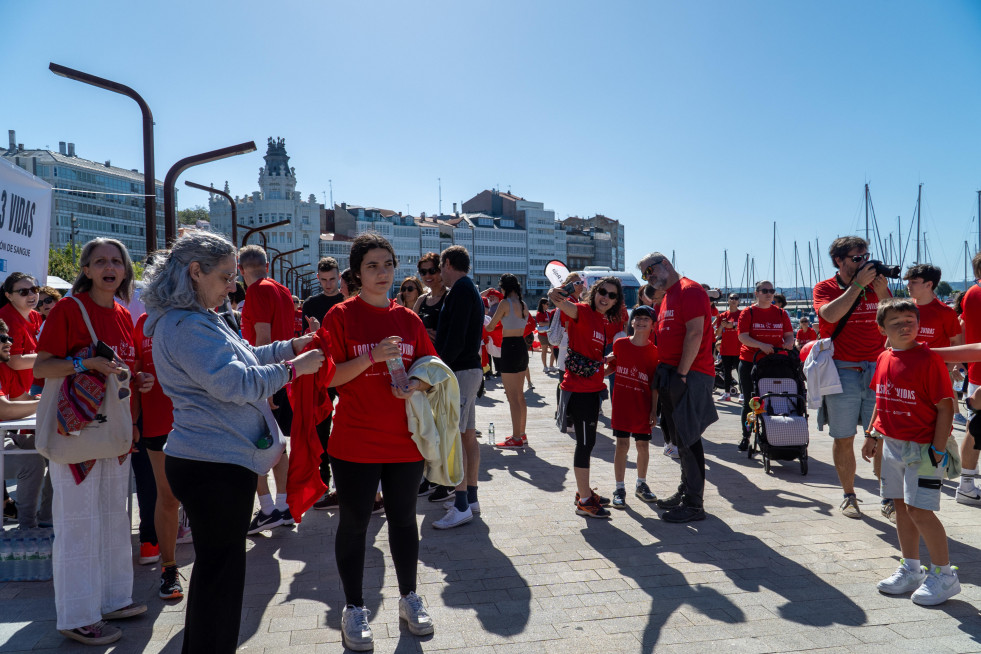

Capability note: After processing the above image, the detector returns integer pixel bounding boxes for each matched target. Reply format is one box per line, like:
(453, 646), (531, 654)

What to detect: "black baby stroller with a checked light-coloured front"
(748, 350), (810, 475)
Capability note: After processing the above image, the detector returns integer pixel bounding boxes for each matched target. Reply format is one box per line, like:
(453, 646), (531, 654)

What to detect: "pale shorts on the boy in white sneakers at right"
(879, 436), (945, 511)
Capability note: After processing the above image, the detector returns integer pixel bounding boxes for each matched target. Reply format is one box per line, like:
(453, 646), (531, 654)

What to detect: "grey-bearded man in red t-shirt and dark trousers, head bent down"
(637, 252), (719, 522)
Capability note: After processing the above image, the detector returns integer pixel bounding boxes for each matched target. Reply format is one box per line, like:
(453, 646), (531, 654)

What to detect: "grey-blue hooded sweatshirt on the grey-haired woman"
(143, 308), (294, 475)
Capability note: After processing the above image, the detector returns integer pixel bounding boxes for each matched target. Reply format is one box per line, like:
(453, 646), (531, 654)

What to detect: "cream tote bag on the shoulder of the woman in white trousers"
(34, 297), (133, 465)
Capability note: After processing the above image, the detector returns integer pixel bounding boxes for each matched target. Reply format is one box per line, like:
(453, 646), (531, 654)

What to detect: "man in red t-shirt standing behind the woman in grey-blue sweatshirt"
(238, 245), (296, 534)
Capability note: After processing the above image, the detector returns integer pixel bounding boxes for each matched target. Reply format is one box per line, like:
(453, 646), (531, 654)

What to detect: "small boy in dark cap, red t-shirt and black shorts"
(606, 305), (659, 509)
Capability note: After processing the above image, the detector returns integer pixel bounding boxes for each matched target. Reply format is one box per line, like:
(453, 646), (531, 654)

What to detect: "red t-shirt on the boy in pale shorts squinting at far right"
(870, 344), (954, 443)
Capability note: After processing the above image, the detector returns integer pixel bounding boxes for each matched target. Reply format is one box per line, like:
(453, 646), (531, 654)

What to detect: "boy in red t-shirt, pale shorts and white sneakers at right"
(862, 298), (961, 606)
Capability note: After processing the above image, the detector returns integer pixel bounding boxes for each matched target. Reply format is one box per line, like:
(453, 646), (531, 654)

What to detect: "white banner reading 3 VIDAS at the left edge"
(0, 159), (52, 286)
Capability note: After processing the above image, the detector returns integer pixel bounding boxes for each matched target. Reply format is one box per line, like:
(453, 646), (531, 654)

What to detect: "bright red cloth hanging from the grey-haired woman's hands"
(286, 327), (335, 523)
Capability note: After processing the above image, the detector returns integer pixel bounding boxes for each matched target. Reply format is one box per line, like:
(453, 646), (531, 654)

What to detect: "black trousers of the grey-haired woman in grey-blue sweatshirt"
(165, 456), (257, 654)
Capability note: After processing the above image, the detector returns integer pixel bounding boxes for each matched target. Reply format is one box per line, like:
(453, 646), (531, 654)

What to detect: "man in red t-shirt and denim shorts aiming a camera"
(814, 236), (899, 518)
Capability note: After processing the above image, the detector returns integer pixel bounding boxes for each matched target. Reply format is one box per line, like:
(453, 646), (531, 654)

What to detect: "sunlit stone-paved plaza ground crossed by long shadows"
(0, 366), (981, 654)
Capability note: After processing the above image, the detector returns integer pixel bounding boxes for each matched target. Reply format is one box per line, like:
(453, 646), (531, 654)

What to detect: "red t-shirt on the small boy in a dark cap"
(610, 338), (658, 434)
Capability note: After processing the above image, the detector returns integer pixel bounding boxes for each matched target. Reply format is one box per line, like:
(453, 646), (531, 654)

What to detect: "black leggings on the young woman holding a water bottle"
(330, 457), (425, 606)
